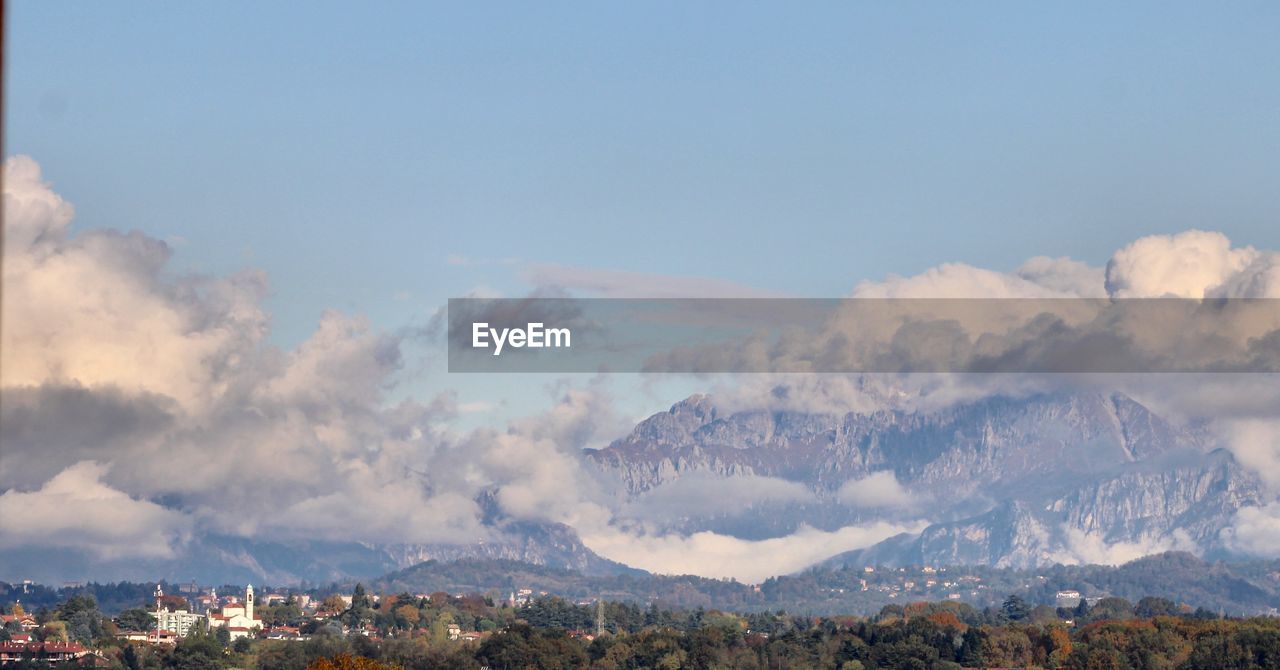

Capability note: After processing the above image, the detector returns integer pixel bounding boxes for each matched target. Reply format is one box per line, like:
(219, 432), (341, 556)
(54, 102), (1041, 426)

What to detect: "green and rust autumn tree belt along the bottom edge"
(7, 587), (1280, 670)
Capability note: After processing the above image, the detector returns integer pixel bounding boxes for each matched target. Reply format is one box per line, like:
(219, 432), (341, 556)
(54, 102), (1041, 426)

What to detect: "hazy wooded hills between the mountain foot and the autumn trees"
(10, 552), (1280, 615)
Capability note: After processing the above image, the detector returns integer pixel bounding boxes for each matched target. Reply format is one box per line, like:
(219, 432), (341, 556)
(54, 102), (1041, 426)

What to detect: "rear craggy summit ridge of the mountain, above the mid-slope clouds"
(588, 395), (1203, 493)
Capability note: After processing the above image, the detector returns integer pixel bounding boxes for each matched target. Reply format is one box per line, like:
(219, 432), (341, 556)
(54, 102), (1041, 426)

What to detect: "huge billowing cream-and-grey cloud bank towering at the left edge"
(0, 156), (485, 553)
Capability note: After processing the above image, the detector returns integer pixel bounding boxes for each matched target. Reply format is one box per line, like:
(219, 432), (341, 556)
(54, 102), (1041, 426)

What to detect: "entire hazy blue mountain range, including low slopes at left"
(0, 392), (1268, 583)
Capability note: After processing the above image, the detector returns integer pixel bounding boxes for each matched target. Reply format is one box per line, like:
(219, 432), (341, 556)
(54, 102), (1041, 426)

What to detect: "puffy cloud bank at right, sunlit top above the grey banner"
(644, 231), (1280, 373)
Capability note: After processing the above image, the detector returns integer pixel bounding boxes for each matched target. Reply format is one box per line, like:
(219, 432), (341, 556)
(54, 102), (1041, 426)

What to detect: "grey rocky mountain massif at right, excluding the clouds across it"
(586, 393), (1263, 566)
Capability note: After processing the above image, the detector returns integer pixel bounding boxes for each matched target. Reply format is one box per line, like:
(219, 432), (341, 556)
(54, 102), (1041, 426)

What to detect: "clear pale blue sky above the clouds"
(5, 1), (1280, 425)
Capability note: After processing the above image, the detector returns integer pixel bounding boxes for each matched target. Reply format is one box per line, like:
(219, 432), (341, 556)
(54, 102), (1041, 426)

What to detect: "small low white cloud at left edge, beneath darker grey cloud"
(0, 461), (192, 559)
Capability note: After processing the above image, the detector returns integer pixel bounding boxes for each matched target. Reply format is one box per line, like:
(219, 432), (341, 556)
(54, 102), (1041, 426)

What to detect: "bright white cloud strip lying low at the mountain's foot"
(582, 521), (925, 583)
